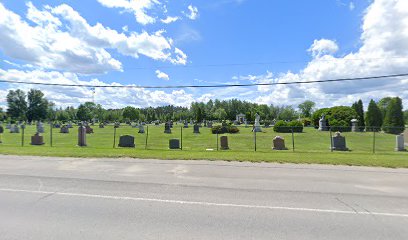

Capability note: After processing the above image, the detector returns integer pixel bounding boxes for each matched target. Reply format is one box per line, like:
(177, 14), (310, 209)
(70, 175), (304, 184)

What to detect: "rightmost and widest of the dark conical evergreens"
(383, 97), (405, 134)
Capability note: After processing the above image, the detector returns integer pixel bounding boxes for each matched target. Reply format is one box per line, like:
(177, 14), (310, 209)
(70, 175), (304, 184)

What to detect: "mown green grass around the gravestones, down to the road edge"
(0, 124), (408, 167)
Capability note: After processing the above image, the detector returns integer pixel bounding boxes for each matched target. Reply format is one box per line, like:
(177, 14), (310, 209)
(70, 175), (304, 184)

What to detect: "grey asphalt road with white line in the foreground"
(0, 156), (408, 240)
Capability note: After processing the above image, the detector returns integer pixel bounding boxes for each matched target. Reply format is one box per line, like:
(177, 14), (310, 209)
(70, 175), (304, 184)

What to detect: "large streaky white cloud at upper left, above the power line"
(0, 2), (187, 74)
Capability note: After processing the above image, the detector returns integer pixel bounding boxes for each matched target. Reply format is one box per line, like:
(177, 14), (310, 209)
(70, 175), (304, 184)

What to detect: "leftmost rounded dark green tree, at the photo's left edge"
(7, 89), (27, 120)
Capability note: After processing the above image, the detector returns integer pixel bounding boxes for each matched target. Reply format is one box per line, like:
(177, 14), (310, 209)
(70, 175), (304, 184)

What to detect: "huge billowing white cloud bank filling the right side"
(248, 0), (408, 107)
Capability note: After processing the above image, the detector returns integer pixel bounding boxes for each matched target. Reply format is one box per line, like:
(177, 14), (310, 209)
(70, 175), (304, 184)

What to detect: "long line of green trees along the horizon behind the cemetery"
(0, 89), (408, 133)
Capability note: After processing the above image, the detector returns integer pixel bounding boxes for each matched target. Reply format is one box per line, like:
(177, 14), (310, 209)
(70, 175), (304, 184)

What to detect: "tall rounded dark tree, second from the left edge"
(27, 89), (48, 122)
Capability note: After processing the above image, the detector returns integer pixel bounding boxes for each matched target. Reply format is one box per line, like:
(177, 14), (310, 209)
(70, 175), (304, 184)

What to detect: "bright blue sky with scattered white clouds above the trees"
(0, 0), (408, 108)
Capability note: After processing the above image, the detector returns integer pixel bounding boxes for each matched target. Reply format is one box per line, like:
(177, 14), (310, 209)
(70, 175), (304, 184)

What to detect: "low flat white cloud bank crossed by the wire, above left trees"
(0, 69), (198, 108)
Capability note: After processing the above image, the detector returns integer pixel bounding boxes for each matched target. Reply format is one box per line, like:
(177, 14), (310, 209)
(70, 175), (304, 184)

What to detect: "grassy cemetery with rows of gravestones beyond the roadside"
(0, 122), (408, 167)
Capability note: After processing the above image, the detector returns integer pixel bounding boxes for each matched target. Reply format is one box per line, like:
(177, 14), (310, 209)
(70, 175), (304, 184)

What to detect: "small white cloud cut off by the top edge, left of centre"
(98, 0), (160, 25)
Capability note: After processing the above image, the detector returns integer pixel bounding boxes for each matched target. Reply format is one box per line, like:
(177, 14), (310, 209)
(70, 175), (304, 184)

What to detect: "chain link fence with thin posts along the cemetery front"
(0, 123), (408, 153)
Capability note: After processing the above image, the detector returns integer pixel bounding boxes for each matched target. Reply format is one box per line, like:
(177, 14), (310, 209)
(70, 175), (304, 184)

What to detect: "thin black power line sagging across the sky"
(0, 73), (408, 89)
